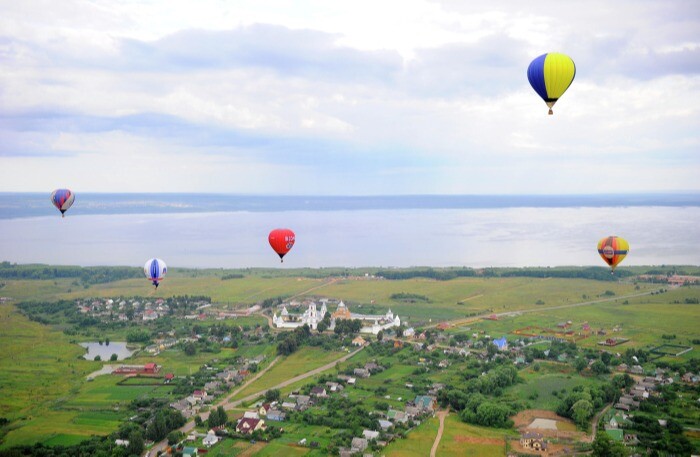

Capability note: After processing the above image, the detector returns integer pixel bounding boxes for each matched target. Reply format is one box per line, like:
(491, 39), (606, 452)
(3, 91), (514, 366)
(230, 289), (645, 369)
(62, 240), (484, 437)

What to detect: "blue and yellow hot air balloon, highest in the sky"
(527, 52), (576, 114)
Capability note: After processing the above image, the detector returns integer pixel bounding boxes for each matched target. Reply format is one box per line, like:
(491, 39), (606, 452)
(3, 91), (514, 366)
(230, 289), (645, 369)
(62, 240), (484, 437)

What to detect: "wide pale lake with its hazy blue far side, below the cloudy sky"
(0, 194), (700, 268)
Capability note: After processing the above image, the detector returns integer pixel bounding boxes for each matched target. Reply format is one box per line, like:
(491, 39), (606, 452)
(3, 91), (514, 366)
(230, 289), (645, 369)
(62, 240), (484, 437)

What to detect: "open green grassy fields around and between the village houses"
(0, 270), (700, 450)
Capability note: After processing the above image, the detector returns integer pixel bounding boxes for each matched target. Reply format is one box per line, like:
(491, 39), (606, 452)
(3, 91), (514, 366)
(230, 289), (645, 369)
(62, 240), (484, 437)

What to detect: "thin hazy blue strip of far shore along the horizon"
(0, 191), (700, 219)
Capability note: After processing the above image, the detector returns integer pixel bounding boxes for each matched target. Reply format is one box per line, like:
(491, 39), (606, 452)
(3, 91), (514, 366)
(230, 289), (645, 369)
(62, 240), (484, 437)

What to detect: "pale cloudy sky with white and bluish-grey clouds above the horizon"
(0, 0), (700, 195)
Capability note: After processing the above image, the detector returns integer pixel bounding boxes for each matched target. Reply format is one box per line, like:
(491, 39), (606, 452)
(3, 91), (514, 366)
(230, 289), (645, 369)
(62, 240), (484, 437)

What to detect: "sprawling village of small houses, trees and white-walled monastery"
(6, 276), (700, 456)
